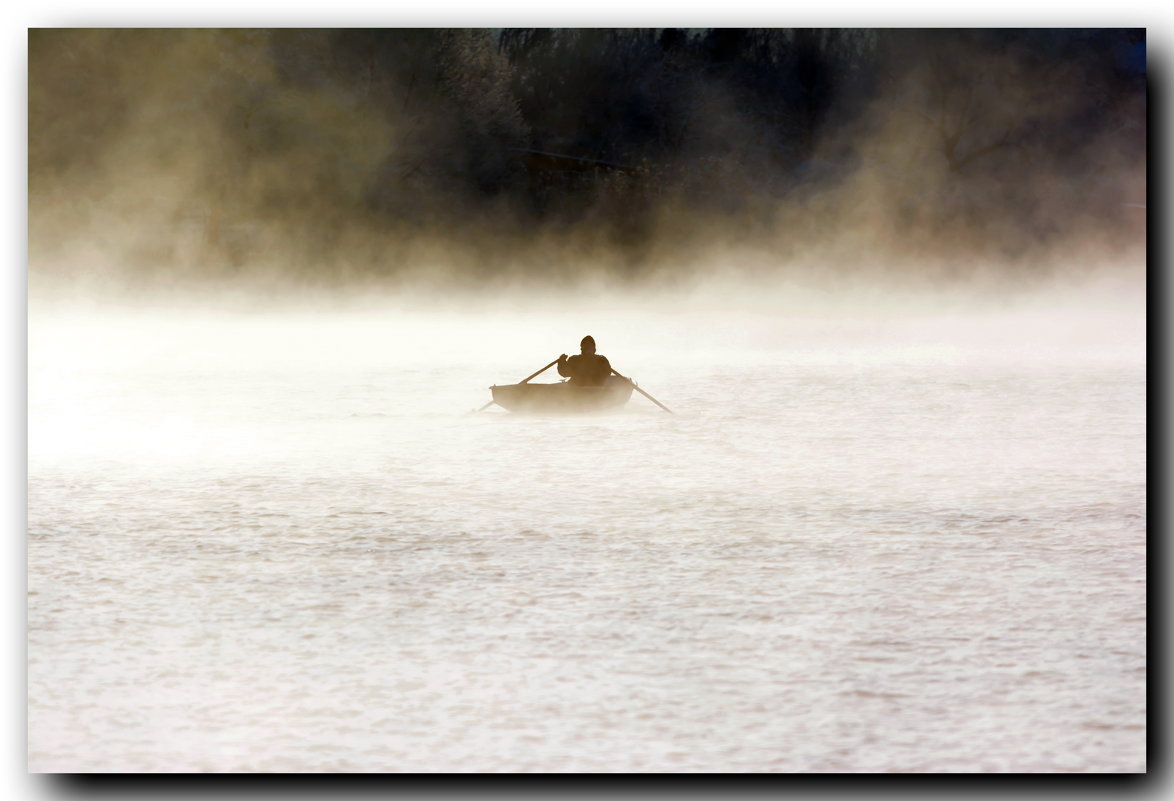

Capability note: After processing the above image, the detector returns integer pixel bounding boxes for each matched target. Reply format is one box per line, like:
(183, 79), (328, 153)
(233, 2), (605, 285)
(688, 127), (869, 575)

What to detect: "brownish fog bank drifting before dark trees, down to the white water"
(29, 29), (1146, 294)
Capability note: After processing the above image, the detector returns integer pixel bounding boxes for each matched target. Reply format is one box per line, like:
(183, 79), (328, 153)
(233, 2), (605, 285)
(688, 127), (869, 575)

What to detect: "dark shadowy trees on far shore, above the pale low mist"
(29, 28), (1146, 277)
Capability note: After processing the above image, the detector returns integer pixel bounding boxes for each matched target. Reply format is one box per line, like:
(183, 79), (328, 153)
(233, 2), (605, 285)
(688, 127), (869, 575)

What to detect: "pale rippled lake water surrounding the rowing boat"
(28, 298), (1146, 772)
